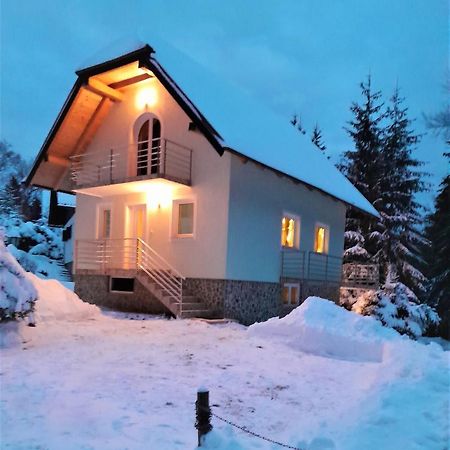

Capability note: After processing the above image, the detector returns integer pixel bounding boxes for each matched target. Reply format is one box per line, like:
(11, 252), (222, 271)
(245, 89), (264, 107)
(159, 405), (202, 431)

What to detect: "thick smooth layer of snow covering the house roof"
(84, 38), (378, 216)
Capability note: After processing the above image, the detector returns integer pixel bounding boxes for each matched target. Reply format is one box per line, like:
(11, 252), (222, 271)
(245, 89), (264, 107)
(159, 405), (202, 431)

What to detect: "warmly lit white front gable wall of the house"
(75, 74), (231, 278)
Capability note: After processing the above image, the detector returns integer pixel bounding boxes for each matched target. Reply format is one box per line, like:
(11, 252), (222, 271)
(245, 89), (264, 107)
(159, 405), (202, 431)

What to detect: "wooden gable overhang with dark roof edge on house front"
(25, 45), (224, 192)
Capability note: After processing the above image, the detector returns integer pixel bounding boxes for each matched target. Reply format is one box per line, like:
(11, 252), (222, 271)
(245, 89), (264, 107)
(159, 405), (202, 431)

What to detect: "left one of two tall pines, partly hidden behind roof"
(338, 76), (385, 262)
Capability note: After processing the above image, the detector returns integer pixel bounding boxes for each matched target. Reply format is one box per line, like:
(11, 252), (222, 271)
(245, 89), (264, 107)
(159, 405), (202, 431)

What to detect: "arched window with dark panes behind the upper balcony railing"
(136, 118), (161, 176)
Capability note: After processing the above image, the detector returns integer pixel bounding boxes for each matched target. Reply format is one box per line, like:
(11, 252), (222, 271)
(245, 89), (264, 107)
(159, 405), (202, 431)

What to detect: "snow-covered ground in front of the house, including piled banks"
(0, 275), (450, 450)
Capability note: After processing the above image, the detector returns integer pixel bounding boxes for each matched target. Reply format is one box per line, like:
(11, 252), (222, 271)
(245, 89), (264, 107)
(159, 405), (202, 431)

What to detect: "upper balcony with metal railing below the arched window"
(70, 139), (192, 190)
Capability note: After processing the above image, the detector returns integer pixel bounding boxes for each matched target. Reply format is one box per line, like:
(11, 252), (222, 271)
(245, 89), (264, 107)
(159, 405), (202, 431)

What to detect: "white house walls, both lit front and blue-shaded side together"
(75, 74), (345, 282)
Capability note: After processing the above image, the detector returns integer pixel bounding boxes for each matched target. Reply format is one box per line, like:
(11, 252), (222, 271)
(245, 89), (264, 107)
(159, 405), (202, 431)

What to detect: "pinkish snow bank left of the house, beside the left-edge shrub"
(26, 273), (100, 325)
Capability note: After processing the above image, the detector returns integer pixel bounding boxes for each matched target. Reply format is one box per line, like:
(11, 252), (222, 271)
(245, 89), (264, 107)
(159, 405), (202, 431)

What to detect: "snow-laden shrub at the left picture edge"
(0, 233), (38, 321)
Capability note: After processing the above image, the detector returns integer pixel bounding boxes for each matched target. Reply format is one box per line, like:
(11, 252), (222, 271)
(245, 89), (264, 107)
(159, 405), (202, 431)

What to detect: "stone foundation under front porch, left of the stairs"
(74, 275), (170, 314)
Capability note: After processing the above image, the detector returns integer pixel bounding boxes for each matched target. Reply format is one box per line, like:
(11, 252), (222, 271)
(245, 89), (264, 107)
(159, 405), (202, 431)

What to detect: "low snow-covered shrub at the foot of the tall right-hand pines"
(349, 283), (440, 338)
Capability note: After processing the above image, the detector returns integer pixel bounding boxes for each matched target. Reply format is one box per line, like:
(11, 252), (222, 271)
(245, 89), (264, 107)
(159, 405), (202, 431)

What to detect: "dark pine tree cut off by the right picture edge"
(426, 153), (450, 338)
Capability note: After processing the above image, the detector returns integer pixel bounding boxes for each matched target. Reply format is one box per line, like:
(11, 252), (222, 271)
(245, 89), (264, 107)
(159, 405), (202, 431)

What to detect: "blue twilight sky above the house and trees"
(0, 0), (450, 204)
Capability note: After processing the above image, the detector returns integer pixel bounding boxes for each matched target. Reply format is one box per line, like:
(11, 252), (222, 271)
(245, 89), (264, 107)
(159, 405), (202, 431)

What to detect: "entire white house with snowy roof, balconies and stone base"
(27, 39), (377, 323)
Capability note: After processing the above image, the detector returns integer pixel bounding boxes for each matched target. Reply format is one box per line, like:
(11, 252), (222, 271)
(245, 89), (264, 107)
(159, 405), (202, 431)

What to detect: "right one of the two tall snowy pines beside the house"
(372, 88), (426, 296)
